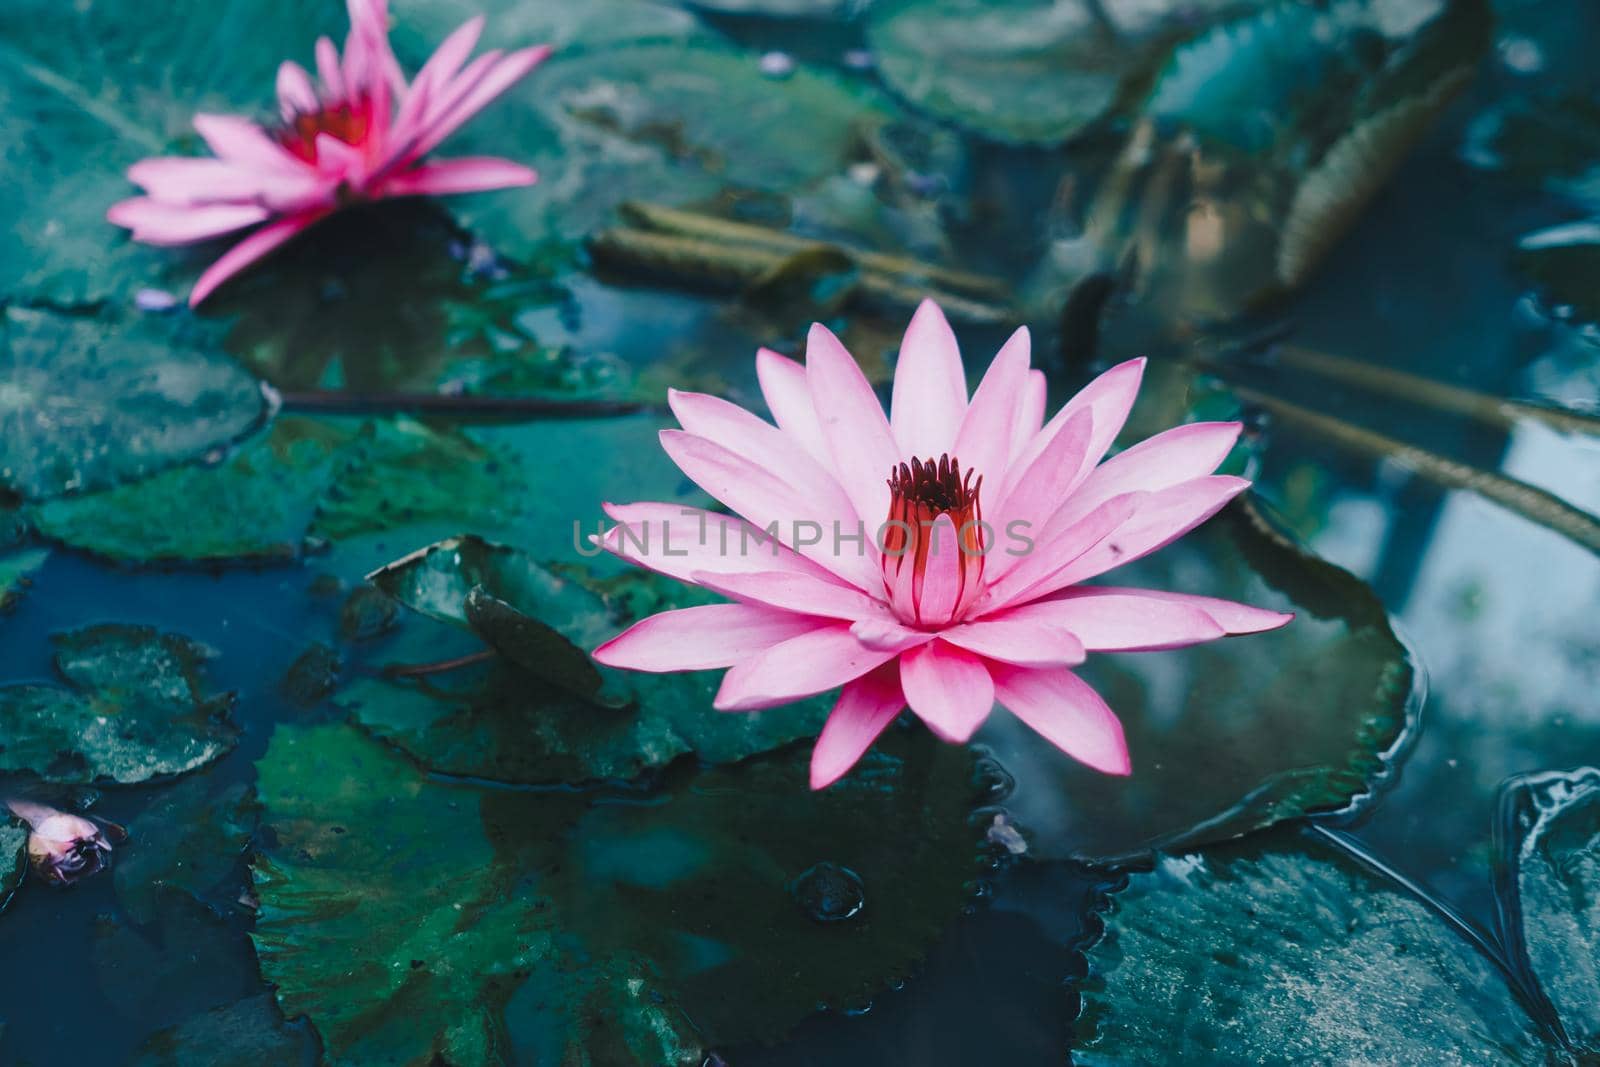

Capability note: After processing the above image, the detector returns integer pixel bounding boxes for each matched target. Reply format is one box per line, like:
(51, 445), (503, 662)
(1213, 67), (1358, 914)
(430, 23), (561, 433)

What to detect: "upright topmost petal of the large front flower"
(885, 299), (966, 463)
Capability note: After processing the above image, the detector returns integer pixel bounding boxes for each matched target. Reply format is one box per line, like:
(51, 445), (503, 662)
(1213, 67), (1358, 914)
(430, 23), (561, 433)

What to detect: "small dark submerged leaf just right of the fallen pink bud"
(112, 776), (258, 923)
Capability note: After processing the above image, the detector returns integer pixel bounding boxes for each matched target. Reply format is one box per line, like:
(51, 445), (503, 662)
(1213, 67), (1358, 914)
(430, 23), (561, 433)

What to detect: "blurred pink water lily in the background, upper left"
(106, 0), (550, 306)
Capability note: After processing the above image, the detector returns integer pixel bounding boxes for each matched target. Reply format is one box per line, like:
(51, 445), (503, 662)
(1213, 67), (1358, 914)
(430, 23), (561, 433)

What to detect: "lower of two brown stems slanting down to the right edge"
(1232, 386), (1600, 553)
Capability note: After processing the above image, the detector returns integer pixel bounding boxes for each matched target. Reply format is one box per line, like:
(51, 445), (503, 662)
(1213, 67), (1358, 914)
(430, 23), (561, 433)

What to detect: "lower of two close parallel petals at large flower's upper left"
(661, 430), (882, 590)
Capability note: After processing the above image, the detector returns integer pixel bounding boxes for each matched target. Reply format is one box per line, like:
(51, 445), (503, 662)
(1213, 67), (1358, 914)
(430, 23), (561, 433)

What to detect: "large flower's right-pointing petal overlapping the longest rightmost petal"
(990, 589), (1226, 653)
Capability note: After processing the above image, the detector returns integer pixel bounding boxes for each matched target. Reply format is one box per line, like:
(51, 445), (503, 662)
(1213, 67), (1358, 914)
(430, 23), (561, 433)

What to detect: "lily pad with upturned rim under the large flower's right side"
(979, 501), (1413, 859)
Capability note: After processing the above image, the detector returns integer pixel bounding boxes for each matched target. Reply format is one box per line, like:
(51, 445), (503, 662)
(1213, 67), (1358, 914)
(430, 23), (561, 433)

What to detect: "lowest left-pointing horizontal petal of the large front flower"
(594, 605), (816, 673)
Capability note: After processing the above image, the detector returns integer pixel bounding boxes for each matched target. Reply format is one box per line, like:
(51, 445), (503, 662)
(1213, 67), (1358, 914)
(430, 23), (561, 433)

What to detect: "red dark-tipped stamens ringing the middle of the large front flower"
(882, 454), (986, 625)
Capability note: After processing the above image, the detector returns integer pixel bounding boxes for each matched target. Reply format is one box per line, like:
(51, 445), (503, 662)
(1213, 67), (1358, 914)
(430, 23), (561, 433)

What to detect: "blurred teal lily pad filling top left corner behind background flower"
(0, 0), (344, 306)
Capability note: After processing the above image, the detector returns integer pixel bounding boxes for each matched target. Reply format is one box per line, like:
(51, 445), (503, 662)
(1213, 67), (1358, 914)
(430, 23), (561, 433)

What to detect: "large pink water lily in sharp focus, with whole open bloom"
(594, 301), (1291, 789)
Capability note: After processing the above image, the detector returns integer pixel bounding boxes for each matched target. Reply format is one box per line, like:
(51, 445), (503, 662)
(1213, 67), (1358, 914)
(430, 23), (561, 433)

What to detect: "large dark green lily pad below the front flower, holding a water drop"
(253, 725), (974, 1064)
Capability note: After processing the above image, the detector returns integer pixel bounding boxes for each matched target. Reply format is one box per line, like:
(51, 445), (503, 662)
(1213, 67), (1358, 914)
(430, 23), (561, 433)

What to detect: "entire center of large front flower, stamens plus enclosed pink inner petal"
(880, 454), (989, 627)
